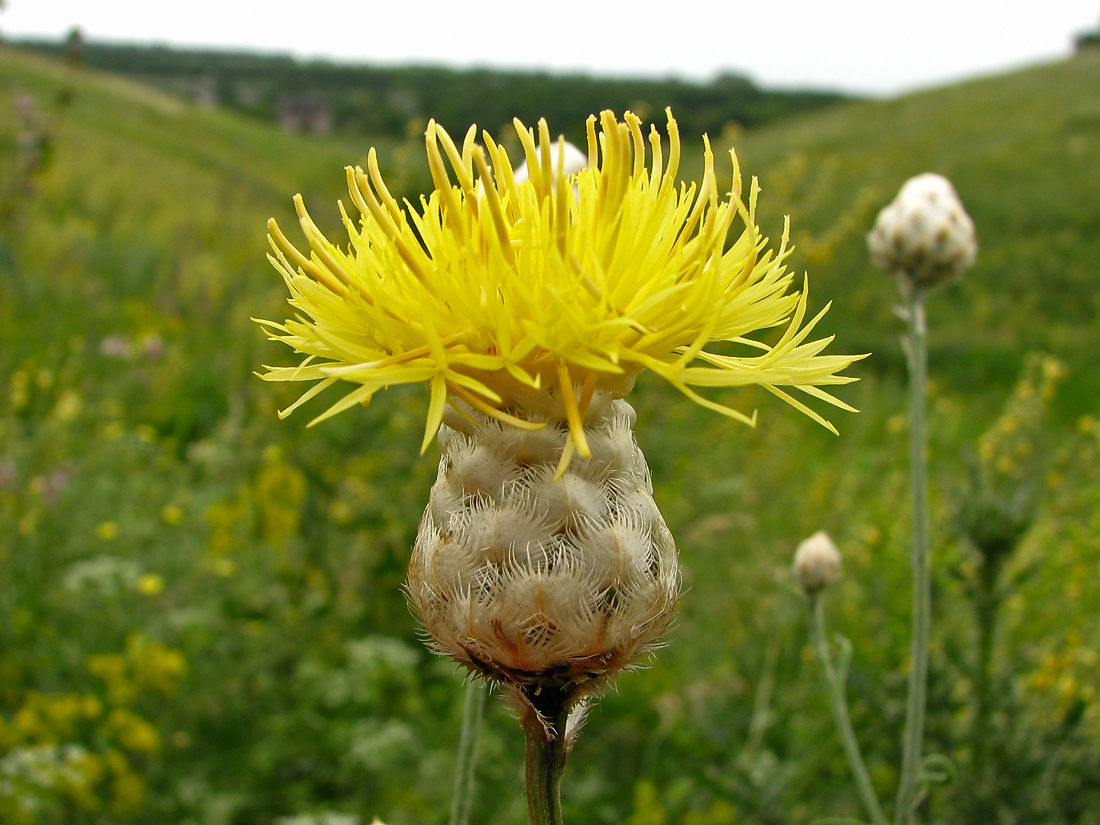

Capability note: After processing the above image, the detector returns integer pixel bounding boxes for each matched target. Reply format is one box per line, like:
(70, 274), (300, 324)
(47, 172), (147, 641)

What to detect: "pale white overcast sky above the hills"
(0, 0), (1100, 96)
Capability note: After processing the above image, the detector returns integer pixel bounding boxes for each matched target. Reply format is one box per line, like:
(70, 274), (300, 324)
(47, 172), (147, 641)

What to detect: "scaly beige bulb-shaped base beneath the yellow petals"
(408, 400), (679, 690)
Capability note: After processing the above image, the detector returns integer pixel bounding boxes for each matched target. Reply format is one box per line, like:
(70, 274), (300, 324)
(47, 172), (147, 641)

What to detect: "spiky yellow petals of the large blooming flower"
(261, 111), (855, 457)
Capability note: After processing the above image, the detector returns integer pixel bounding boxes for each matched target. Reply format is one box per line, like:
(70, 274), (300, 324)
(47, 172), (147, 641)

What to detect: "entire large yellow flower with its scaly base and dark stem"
(261, 112), (856, 825)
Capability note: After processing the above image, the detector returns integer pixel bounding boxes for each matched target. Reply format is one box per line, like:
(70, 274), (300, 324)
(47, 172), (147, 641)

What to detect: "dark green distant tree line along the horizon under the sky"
(15, 41), (845, 142)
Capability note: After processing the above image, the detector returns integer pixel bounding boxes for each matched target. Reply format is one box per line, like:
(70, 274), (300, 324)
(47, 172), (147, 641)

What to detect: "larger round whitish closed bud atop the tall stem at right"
(867, 173), (978, 286)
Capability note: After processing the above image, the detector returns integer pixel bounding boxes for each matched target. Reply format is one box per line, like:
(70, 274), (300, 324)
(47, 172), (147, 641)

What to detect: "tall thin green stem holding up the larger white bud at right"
(895, 284), (932, 825)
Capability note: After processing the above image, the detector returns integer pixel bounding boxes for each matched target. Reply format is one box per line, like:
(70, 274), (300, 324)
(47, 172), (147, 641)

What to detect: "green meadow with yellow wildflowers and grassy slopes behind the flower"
(0, 47), (1100, 825)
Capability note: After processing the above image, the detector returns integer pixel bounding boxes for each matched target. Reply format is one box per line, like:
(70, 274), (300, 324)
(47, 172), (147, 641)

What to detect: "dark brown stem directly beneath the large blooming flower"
(523, 689), (572, 825)
